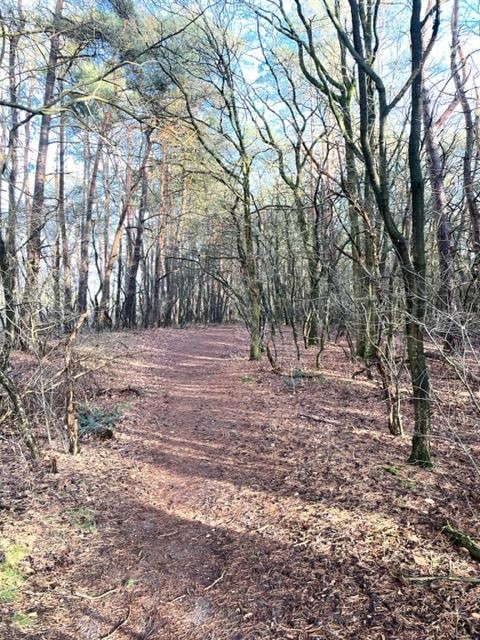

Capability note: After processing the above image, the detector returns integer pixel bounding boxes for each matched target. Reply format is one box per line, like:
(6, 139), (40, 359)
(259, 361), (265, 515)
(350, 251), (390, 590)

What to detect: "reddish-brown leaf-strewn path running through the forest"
(73, 327), (368, 640)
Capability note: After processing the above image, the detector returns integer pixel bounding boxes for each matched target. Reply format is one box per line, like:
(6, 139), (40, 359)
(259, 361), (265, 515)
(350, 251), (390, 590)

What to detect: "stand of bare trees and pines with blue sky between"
(0, 0), (480, 465)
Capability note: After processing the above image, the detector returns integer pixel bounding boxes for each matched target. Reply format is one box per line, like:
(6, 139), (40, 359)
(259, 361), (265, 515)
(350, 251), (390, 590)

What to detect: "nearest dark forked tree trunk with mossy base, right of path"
(349, 0), (438, 467)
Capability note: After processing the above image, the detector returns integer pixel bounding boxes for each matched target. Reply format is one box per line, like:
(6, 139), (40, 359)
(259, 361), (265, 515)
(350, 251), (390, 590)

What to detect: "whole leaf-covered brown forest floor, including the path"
(0, 327), (480, 640)
